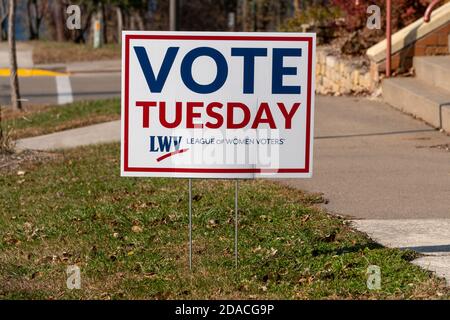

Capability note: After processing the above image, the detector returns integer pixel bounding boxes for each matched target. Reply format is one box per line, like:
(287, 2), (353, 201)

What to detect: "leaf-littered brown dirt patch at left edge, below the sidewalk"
(0, 150), (61, 174)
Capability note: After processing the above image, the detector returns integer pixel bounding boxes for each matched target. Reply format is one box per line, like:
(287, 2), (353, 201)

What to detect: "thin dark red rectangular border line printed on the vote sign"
(123, 34), (313, 173)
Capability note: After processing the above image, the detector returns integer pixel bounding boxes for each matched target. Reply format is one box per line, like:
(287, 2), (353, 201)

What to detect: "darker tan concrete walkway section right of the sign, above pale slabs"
(285, 97), (450, 219)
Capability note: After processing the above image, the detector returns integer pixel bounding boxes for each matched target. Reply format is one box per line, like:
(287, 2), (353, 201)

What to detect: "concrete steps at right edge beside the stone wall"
(382, 56), (450, 133)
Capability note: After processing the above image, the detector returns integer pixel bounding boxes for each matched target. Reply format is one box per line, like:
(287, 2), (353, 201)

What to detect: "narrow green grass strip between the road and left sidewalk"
(2, 99), (120, 138)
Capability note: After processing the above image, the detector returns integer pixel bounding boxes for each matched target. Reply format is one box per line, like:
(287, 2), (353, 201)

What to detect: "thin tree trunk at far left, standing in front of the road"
(8, 0), (22, 109)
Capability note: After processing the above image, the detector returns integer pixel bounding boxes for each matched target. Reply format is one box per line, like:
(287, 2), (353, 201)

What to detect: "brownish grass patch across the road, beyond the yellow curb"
(29, 40), (122, 64)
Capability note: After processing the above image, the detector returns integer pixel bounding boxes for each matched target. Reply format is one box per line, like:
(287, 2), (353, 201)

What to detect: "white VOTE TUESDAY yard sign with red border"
(121, 31), (316, 178)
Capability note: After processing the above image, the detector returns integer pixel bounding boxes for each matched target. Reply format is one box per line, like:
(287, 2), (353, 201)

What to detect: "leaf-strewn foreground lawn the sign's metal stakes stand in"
(0, 144), (449, 299)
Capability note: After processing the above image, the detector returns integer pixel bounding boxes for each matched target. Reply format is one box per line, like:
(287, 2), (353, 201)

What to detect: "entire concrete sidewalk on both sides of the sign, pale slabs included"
(18, 96), (450, 284)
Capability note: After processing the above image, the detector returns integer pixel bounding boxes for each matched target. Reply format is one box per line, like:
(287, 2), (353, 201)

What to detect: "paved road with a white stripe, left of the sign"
(0, 42), (121, 105)
